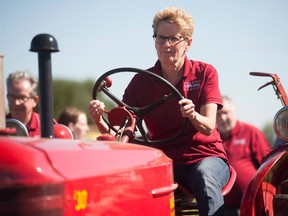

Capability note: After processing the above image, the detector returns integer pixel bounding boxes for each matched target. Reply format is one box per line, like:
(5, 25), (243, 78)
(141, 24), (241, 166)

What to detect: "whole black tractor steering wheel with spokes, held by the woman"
(92, 67), (188, 146)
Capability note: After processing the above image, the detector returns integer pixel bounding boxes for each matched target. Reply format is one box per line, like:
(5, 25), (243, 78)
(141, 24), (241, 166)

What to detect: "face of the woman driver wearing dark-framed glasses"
(155, 21), (192, 65)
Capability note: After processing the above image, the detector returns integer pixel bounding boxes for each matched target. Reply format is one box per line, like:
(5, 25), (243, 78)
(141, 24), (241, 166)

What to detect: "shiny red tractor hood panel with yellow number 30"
(0, 137), (176, 216)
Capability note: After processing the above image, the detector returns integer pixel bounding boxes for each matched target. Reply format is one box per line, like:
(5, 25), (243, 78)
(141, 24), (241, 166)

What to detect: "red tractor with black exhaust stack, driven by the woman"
(0, 34), (288, 216)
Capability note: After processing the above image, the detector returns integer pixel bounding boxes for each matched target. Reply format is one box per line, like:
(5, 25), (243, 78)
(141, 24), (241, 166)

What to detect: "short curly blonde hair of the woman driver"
(152, 7), (194, 37)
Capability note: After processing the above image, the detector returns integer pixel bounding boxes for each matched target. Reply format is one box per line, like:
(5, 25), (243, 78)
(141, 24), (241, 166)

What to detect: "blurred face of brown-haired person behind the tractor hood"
(68, 113), (89, 139)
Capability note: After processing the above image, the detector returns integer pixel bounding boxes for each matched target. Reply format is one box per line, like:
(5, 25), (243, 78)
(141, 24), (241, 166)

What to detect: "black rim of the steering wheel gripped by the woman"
(92, 67), (188, 146)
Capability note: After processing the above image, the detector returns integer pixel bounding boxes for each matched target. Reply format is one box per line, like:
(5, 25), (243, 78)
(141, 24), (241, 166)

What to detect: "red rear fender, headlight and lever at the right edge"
(241, 72), (288, 216)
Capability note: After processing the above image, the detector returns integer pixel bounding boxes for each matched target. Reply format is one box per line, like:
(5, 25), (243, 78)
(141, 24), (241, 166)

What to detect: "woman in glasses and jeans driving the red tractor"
(89, 7), (230, 216)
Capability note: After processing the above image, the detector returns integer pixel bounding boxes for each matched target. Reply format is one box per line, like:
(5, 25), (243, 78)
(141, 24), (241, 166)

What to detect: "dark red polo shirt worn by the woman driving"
(123, 57), (227, 164)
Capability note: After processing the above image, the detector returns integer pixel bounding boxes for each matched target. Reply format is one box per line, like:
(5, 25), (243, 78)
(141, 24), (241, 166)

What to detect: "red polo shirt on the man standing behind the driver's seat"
(223, 121), (270, 207)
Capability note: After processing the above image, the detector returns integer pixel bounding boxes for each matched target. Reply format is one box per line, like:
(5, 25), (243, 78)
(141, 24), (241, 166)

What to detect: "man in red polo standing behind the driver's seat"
(216, 95), (271, 216)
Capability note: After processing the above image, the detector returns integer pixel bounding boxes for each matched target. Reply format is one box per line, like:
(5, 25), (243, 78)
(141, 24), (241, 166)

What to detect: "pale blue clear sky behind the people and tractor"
(0, 0), (288, 128)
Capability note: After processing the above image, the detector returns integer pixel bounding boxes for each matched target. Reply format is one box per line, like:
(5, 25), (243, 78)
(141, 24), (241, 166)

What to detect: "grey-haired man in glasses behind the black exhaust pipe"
(6, 71), (41, 137)
